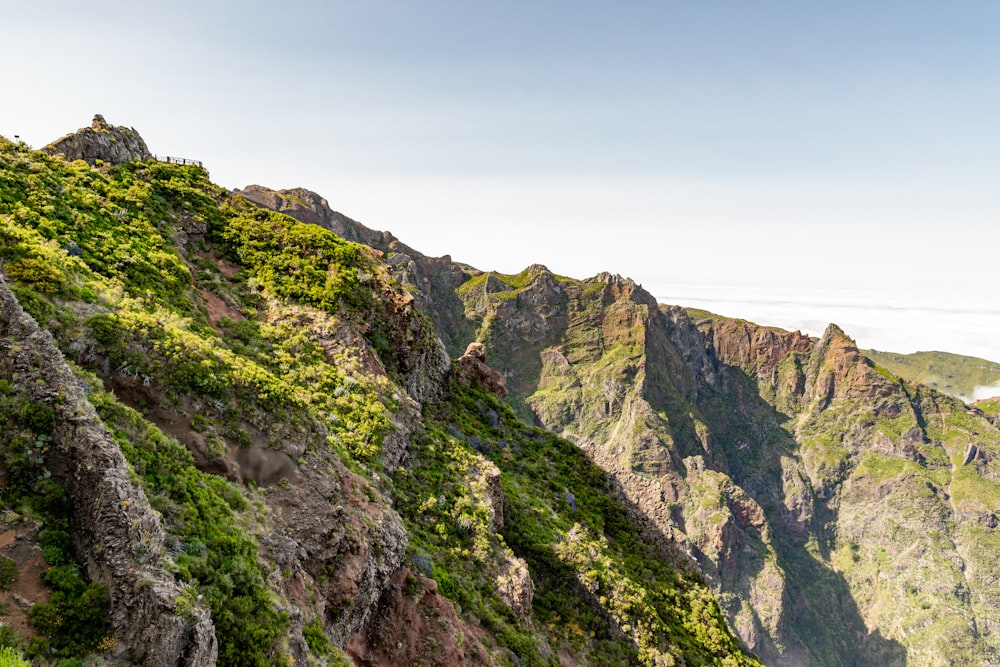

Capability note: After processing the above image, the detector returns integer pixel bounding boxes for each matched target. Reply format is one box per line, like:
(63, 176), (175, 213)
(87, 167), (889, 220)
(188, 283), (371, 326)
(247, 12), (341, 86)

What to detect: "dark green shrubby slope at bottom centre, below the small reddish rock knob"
(396, 389), (756, 666)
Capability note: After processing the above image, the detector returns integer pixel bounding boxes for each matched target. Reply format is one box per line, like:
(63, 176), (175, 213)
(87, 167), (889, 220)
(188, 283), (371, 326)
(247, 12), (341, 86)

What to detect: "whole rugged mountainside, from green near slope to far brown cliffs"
(0, 117), (1000, 667)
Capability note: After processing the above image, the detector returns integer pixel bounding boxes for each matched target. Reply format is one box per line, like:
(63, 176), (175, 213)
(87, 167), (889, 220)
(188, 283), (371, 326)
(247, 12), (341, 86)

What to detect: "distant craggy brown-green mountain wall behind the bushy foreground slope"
(440, 266), (1000, 665)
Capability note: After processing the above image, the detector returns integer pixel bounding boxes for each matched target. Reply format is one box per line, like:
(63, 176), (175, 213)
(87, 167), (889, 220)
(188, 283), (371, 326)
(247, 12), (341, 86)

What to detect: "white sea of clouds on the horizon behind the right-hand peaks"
(656, 286), (1000, 400)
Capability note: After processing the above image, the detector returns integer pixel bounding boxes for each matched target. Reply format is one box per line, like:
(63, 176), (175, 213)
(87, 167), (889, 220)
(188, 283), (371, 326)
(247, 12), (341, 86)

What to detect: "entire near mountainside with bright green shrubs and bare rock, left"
(0, 119), (758, 665)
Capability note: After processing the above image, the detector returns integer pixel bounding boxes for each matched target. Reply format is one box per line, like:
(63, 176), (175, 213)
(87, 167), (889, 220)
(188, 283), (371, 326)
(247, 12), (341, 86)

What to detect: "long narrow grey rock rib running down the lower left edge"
(0, 277), (217, 667)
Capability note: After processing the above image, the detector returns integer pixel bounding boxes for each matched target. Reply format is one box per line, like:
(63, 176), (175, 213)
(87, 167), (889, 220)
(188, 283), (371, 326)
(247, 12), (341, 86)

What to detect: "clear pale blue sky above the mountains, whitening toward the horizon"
(0, 0), (1000, 360)
